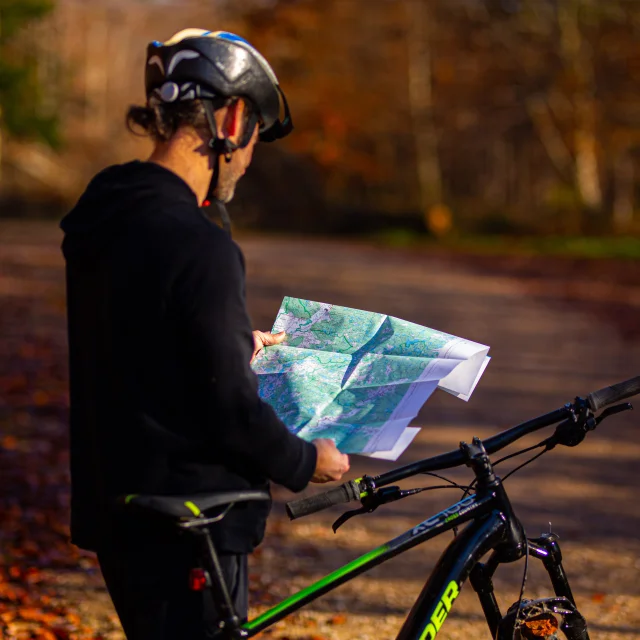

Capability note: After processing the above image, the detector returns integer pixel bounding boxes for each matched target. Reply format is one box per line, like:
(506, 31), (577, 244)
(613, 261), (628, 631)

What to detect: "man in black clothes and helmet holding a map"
(61, 29), (349, 640)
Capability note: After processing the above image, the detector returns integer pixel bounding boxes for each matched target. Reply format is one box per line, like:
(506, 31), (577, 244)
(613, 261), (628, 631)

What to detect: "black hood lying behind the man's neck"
(60, 160), (198, 257)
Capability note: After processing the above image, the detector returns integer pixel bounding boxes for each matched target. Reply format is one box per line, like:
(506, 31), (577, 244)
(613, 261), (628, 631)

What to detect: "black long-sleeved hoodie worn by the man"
(61, 162), (316, 553)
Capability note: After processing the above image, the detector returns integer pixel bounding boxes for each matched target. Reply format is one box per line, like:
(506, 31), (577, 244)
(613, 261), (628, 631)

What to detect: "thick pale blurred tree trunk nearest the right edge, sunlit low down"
(558, 0), (602, 210)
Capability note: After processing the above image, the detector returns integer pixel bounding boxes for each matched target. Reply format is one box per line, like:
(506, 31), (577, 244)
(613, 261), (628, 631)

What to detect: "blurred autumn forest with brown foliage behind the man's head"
(0, 0), (640, 242)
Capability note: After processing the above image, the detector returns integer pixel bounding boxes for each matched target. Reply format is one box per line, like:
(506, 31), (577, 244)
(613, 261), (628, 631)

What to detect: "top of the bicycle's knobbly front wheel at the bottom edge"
(496, 597), (589, 640)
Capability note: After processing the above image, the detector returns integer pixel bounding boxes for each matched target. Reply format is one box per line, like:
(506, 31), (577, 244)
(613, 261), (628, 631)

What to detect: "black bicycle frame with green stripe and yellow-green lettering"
(196, 481), (588, 640)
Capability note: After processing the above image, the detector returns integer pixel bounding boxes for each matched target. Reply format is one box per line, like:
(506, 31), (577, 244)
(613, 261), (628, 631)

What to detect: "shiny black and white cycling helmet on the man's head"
(145, 29), (293, 146)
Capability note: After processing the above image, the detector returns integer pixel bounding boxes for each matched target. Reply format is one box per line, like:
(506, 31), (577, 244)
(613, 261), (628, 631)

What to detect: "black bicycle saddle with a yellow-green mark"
(120, 490), (271, 518)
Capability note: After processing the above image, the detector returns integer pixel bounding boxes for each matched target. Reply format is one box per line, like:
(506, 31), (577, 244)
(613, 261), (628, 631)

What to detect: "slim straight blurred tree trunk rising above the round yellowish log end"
(405, 0), (442, 215)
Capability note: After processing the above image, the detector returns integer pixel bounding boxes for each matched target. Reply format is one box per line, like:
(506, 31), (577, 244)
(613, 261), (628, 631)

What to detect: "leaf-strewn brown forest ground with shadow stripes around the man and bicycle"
(0, 222), (640, 640)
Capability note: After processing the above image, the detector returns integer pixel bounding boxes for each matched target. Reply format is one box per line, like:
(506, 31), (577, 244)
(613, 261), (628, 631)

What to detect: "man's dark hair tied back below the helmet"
(126, 98), (249, 142)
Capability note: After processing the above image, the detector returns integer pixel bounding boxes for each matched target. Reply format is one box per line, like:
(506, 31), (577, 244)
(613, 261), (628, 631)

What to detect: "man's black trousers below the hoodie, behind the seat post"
(98, 544), (248, 640)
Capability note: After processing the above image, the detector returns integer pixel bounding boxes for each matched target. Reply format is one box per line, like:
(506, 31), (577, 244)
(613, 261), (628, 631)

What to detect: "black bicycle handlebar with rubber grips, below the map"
(286, 376), (640, 520)
